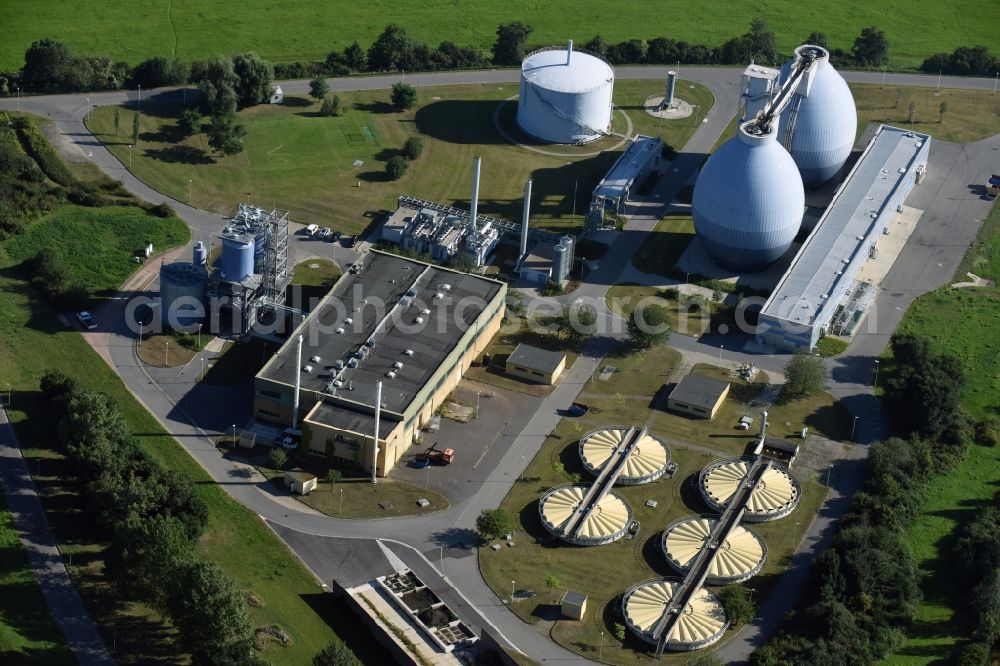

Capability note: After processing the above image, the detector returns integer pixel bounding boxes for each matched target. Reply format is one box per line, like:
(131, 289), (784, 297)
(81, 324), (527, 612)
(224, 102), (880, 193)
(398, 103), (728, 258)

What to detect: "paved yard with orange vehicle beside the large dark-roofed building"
(389, 379), (539, 505)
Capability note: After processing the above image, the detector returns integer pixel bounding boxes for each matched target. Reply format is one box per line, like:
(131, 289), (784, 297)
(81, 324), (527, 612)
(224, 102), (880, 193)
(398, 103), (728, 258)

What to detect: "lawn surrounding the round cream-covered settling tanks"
(479, 352), (825, 664)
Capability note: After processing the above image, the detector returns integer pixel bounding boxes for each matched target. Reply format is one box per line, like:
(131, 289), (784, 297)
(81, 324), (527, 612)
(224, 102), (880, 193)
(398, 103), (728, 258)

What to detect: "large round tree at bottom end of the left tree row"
(168, 561), (253, 664)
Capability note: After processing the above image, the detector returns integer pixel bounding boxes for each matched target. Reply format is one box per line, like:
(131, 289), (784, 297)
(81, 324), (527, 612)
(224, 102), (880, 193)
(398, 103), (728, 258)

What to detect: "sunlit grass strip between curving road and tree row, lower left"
(0, 212), (364, 664)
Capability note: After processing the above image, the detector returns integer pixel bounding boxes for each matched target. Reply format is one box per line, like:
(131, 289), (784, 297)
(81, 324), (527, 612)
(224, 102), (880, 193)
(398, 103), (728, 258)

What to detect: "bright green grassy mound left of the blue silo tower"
(3, 205), (191, 298)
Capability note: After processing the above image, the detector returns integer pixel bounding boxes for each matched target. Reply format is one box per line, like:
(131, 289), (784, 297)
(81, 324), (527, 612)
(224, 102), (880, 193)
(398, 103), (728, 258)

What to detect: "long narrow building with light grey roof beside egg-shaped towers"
(757, 125), (931, 351)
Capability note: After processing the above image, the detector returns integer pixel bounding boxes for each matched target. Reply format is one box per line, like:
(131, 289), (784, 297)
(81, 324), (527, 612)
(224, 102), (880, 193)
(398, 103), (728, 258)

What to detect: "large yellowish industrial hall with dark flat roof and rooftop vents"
(254, 252), (507, 475)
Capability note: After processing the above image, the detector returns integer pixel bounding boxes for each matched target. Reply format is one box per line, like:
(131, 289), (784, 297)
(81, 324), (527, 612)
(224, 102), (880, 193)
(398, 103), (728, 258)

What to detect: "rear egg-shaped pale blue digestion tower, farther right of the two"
(778, 44), (858, 189)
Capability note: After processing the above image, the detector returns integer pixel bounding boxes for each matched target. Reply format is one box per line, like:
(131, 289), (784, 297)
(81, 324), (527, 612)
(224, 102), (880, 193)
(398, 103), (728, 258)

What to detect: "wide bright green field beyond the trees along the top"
(0, 0), (1000, 69)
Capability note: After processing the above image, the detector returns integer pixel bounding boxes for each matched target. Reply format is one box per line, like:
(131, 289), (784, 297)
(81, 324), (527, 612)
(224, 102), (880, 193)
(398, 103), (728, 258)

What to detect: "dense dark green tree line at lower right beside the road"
(751, 334), (1000, 666)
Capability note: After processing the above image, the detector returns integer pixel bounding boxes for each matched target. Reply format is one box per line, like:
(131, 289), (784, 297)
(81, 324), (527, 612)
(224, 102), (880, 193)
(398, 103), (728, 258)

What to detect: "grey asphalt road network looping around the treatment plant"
(0, 67), (1000, 663)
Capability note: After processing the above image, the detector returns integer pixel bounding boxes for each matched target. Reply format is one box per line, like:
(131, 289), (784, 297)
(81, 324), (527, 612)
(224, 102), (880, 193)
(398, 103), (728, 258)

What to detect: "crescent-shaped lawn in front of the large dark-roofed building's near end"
(257, 456), (450, 519)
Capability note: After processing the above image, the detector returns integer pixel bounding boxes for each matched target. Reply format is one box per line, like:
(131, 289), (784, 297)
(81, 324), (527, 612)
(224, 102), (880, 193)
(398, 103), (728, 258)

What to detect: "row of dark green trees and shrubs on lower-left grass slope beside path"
(41, 370), (264, 664)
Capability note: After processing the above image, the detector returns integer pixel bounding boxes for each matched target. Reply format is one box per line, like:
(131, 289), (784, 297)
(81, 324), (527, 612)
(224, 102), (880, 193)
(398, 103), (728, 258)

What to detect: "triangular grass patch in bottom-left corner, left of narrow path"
(0, 494), (76, 666)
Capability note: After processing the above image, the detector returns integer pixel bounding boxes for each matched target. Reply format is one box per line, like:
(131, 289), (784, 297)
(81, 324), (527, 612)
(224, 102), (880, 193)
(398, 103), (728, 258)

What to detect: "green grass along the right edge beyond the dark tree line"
(885, 206), (1000, 666)
